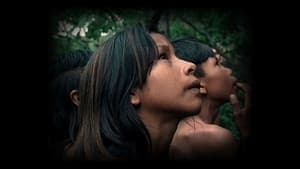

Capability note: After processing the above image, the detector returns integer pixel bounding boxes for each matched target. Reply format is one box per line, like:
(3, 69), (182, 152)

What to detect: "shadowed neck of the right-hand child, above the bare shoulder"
(198, 98), (222, 124)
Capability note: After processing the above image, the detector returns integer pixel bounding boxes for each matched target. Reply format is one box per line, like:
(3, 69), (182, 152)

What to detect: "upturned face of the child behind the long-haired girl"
(201, 55), (236, 102)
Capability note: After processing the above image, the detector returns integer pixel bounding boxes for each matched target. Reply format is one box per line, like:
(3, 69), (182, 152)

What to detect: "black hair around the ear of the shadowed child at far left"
(48, 67), (83, 141)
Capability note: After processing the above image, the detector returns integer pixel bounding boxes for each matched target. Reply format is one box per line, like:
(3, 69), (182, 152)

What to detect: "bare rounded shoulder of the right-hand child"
(170, 118), (236, 158)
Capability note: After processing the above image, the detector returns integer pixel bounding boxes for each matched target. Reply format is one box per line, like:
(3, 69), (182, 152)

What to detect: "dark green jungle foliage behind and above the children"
(48, 8), (253, 139)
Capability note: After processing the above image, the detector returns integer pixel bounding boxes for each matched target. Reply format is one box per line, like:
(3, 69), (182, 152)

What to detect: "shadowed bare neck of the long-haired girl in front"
(139, 111), (179, 159)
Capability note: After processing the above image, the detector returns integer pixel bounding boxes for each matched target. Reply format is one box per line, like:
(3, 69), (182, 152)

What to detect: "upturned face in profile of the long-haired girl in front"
(132, 33), (201, 117)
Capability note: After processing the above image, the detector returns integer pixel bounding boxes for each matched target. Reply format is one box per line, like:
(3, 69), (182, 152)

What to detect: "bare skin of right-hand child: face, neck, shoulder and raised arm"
(169, 51), (250, 160)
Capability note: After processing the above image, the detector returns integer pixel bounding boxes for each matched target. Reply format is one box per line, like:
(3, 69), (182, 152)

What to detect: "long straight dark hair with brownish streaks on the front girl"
(69, 24), (158, 160)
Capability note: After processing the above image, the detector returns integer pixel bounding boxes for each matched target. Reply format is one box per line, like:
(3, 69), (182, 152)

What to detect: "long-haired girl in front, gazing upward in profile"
(66, 25), (201, 161)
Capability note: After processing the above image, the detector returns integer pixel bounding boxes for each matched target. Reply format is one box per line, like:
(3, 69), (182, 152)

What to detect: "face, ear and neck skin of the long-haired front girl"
(131, 33), (201, 159)
